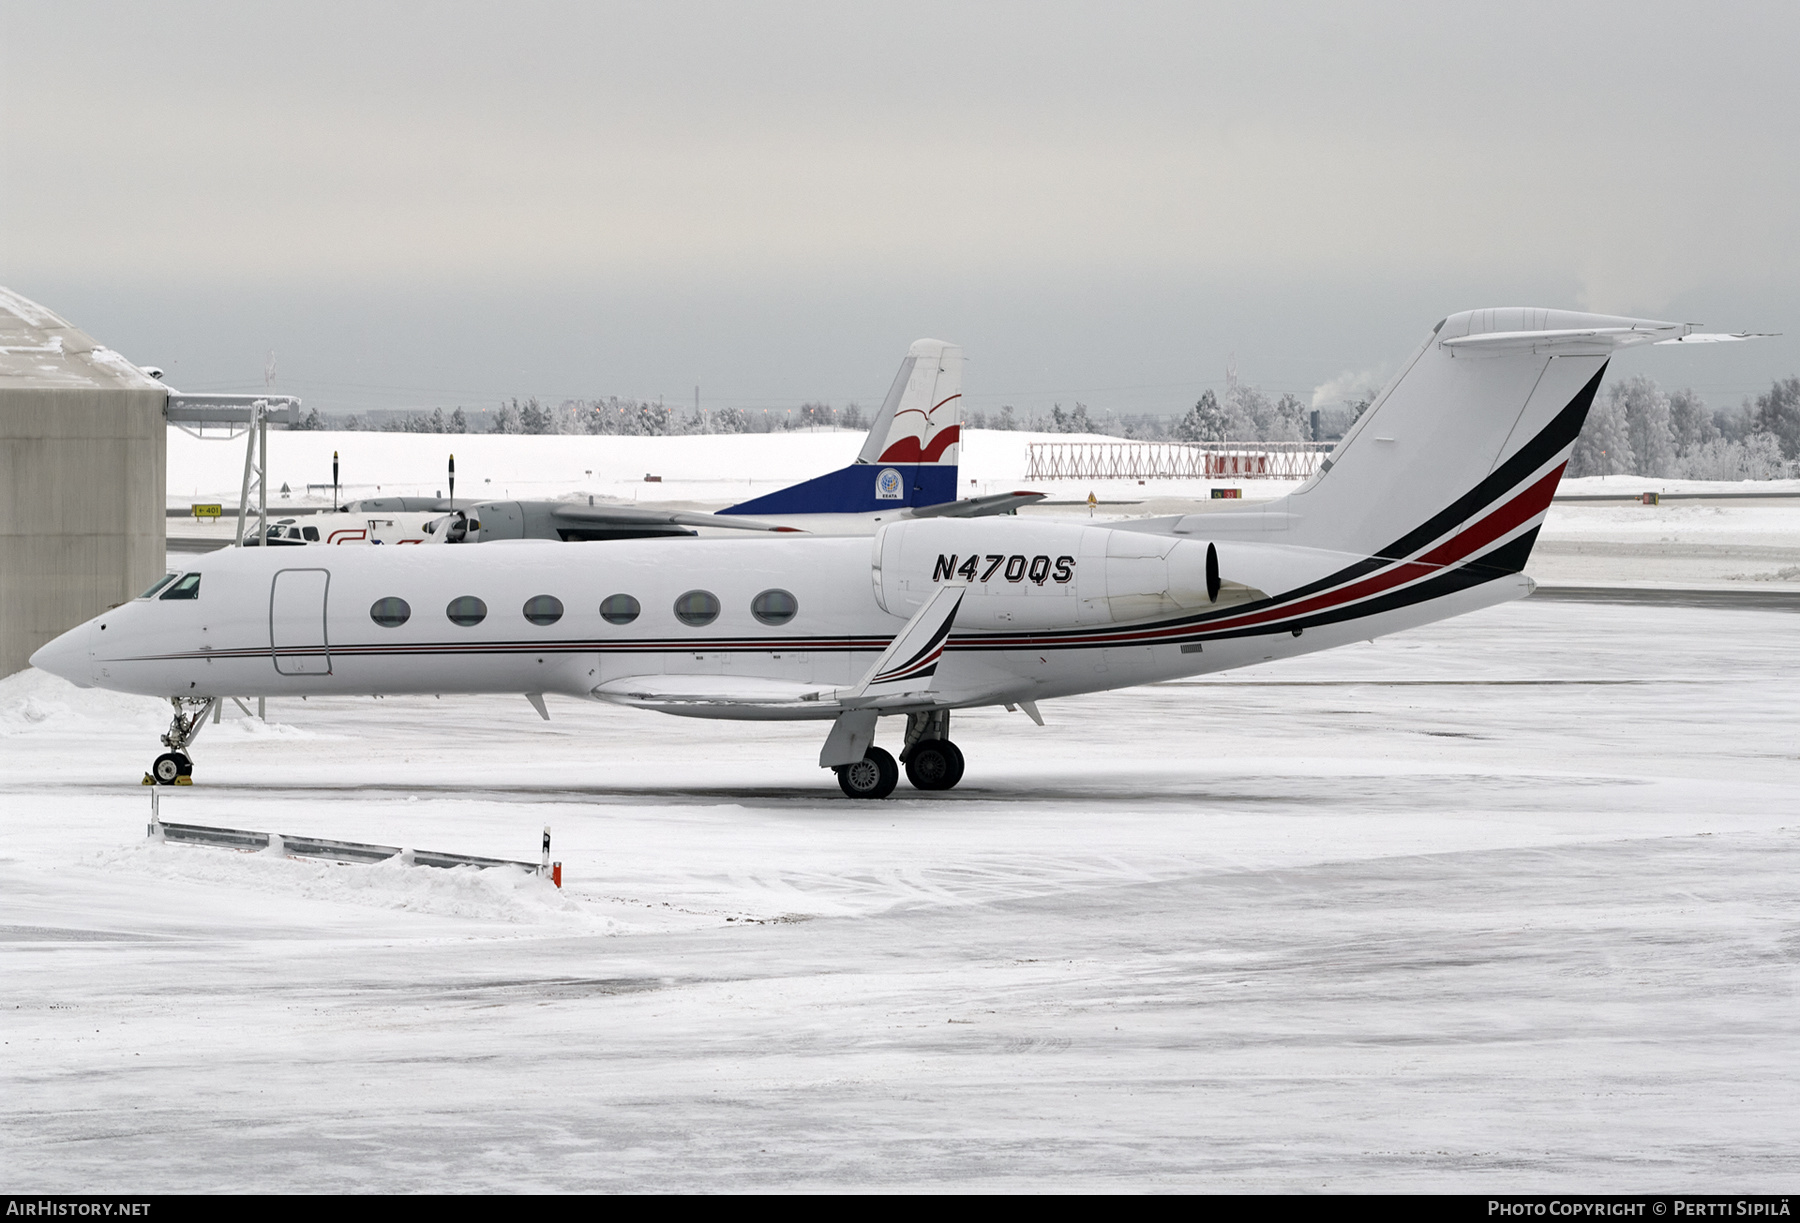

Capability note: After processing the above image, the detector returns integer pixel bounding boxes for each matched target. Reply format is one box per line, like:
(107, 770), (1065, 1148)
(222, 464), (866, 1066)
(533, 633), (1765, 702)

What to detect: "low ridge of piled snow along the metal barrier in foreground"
(92, 841), (625, 935)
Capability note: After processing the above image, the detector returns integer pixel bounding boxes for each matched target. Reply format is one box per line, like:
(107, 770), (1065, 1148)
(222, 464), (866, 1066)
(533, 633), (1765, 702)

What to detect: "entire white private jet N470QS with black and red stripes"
(32, 308), (1756, 798)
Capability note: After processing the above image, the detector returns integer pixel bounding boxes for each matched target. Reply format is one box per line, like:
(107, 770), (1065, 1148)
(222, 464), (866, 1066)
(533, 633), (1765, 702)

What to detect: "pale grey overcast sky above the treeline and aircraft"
(0, 0), (1800, 411)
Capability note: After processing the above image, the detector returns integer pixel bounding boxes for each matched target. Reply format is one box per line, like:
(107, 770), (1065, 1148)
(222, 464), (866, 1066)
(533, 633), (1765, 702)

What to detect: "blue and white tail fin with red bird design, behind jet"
(720, 340), (963, 517)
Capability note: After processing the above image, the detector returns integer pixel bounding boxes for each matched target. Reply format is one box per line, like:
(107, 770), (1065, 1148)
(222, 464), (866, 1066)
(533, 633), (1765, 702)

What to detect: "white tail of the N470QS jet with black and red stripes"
(1245, 308), (1687, 573)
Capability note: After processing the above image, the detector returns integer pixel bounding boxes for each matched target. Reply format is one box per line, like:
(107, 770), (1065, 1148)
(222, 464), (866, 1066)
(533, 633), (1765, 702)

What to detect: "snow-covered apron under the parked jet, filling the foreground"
(0, 600), (1800, 1192)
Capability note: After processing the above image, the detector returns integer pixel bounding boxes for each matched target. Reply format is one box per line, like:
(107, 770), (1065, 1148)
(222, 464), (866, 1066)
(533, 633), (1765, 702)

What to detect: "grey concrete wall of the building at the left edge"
(0, 385), (167, 675)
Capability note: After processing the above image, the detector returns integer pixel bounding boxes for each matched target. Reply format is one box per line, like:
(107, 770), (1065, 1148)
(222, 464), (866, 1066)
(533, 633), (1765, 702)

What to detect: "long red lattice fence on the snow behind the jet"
(1024, 441), (1336, 481)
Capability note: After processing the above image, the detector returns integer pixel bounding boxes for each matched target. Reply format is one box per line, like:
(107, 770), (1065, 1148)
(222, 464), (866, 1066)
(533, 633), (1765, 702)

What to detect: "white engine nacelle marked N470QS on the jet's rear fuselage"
(873, 517), (1262, 630)
